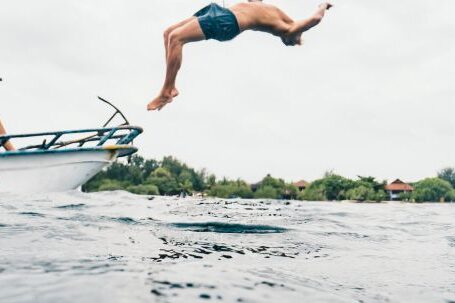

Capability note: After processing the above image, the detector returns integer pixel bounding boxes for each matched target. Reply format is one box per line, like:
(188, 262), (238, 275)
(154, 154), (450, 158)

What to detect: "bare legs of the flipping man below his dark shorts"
(147, 18), (205, 110)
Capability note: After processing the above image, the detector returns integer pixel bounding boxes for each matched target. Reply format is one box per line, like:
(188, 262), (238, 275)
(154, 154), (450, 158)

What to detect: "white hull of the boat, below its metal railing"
(0, 148), (119, 193)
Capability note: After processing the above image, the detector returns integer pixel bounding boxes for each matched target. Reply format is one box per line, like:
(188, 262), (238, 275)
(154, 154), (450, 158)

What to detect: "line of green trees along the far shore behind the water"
(83, 155), (455, 202)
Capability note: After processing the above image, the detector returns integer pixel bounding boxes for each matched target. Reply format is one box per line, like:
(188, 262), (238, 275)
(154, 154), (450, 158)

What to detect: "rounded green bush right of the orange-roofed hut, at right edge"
(411, 178), (455, 202)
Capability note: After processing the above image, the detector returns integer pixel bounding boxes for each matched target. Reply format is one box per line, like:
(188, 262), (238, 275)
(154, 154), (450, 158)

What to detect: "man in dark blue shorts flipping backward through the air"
(147, 0), (332, 110)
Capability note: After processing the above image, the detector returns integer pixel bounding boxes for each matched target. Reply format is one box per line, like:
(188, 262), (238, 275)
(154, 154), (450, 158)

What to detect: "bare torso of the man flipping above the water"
(229, 2), (293, 37)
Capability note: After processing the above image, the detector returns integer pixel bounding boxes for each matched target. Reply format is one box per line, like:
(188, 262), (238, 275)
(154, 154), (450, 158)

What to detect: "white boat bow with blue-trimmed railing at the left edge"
(0, 126), (142, 193)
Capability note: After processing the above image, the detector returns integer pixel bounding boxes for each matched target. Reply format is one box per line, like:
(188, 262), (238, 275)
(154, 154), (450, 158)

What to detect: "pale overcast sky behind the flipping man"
(0, 0), (455, 182)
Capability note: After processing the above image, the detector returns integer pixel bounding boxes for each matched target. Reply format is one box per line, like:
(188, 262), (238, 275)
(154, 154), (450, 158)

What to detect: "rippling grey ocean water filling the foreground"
(0, 192), (455, 303)
